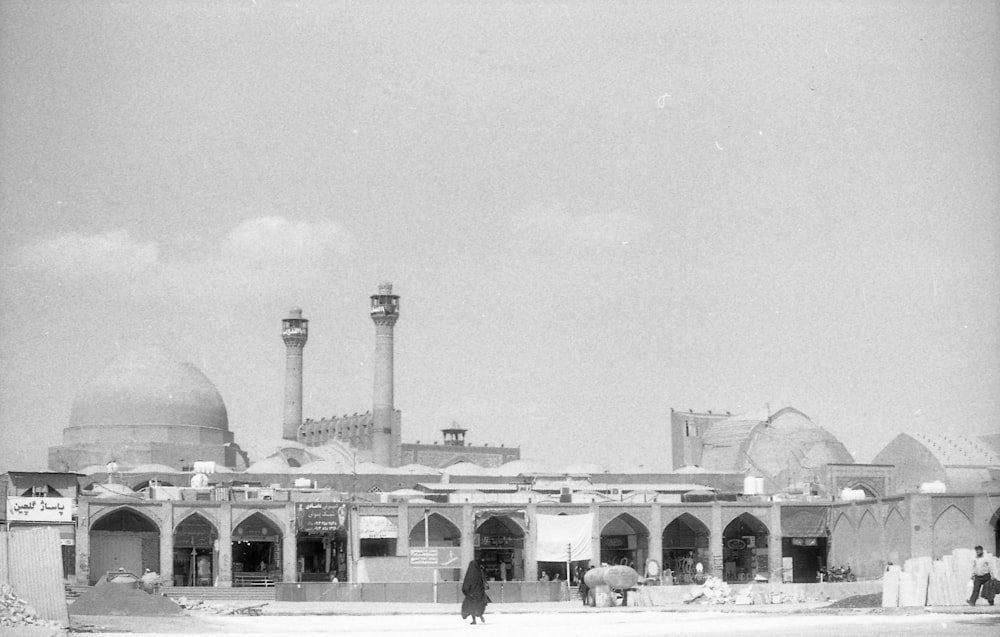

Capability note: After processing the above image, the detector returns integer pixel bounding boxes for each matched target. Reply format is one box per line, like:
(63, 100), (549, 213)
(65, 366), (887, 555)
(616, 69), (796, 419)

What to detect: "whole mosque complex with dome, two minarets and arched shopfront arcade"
(0, 283), (1000, 587)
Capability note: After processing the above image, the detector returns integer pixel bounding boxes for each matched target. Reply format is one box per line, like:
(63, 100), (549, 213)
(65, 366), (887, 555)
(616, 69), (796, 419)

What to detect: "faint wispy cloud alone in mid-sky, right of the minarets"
(510, 203), (643, 248)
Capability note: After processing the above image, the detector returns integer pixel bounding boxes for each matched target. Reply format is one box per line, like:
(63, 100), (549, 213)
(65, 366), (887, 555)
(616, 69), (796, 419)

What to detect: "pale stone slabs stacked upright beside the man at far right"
(882, 548), (1000, 608)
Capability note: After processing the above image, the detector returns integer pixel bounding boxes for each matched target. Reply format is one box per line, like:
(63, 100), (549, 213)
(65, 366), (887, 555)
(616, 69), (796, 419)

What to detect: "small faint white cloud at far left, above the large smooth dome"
(13, 230), (160, 279)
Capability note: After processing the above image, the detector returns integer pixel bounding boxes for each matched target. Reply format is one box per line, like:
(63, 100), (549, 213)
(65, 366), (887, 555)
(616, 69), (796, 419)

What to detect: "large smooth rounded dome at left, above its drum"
(69, 347), (229, 431)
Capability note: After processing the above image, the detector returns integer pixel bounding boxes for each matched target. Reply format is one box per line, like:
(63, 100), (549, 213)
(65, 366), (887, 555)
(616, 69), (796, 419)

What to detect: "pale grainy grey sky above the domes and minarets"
(0, 0), (1000, 470)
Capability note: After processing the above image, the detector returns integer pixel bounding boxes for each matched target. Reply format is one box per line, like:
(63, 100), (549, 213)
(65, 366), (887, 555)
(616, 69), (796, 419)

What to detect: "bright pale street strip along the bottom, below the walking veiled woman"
(74, 610), (1000, 637)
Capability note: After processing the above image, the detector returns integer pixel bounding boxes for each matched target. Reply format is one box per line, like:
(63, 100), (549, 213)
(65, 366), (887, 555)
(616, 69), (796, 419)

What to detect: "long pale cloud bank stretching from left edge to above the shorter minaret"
(13, 216), (354, 298)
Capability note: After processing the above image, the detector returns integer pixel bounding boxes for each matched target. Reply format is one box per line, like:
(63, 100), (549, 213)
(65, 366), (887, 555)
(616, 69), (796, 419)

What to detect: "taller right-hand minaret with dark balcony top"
(371, 283), (399, 467)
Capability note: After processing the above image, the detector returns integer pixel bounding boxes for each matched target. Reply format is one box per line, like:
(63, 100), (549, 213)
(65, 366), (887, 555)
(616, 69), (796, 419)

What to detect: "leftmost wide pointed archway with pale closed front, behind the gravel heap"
(89, 508), (160, 584)
